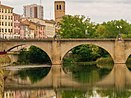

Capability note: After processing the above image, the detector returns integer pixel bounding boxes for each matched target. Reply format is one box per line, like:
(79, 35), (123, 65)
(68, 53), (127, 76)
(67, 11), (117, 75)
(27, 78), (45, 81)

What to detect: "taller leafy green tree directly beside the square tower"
(58, 15), (95, 38)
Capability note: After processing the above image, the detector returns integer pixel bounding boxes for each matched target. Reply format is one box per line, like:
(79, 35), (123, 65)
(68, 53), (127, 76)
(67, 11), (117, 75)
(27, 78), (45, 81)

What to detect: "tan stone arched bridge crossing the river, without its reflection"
(0, 39), (131, 65)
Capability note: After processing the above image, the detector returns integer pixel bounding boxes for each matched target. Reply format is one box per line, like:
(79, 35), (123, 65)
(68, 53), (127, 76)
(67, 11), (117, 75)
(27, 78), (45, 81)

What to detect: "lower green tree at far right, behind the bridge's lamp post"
(94, 19), (131, 38)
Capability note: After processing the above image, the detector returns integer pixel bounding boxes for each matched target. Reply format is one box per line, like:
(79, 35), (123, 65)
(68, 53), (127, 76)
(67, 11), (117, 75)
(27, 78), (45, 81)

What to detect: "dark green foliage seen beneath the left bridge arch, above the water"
(18, 46), (51, 64)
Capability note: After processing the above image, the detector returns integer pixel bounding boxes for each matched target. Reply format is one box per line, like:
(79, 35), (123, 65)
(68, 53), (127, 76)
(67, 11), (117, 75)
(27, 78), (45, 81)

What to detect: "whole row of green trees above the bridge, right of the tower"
(57, 15), (131, 38)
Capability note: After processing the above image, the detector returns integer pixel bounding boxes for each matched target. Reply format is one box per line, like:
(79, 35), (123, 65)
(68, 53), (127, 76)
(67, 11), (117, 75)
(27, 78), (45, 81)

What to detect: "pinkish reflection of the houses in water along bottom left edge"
(4, 90), (56, 98)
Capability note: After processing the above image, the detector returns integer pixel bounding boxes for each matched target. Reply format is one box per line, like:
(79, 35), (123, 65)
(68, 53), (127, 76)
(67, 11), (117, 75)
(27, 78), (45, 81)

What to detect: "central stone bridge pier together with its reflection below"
(51, 40), (62, 89)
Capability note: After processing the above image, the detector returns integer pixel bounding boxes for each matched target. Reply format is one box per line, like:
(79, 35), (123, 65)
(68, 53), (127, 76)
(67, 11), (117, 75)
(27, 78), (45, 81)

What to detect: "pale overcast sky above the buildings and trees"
(1, 0), (131, 22)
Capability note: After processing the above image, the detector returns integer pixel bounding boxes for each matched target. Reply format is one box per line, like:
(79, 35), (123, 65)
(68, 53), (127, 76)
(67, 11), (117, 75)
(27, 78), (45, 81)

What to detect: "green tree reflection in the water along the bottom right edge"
(62, 89), (131, 98)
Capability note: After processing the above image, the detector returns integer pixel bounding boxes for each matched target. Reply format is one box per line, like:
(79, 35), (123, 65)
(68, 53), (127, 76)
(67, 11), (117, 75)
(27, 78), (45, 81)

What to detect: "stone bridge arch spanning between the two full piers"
(61, 42), (114, 61)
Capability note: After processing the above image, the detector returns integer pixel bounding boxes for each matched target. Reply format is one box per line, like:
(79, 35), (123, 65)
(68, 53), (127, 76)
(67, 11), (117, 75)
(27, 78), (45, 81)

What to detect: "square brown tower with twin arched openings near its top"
(54, 1), (65, 23)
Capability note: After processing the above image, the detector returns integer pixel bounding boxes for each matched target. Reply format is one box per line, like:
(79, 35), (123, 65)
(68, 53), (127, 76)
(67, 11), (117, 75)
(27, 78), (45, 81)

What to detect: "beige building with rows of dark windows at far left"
(0, 2), (13, 38)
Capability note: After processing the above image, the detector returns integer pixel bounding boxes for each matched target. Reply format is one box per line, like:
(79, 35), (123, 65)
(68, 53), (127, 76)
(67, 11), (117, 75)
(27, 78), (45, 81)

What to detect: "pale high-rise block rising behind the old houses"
(24, 4), (43, 19)
